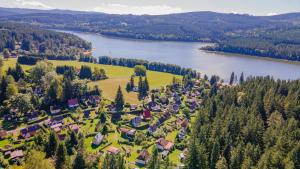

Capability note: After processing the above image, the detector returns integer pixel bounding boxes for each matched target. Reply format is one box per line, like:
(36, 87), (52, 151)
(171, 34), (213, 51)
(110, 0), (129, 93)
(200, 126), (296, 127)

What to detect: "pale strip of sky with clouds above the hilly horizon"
(0, 0), (300, 15)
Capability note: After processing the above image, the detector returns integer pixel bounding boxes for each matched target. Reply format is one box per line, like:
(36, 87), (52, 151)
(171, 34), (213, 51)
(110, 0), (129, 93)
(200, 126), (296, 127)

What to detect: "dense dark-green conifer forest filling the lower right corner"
(185, 77), (300, 169)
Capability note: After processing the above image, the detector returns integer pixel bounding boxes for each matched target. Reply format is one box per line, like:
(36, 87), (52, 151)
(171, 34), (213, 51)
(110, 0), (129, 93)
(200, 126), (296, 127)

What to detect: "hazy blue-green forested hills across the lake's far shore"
(0, 8), (300, 61)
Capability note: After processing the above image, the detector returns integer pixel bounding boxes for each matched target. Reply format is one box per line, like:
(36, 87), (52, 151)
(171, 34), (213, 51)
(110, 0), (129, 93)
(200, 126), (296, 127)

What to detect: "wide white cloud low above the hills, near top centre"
(86, 3), (184, 15)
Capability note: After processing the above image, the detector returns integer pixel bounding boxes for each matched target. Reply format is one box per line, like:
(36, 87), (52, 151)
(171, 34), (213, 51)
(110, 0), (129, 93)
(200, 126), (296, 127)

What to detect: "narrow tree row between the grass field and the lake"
(98, 56), (198, 77)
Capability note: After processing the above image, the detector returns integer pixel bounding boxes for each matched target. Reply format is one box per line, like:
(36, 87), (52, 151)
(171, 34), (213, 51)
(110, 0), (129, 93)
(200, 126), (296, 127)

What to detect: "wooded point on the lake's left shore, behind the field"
(0, 22), (91, 56)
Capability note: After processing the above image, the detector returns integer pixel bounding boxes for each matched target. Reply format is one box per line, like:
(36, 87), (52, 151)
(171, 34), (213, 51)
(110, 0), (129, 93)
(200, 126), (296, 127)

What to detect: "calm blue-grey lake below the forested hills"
(65, 31), (300, 81)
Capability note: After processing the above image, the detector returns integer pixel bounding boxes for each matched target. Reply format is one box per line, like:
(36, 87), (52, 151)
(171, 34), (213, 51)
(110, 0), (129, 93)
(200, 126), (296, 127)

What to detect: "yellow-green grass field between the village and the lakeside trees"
(3, 59), (180, 104)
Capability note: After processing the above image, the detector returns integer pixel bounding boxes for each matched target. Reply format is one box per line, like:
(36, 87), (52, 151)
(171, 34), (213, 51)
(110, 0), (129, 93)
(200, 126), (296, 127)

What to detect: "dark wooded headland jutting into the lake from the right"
(203, 29), (300, 61)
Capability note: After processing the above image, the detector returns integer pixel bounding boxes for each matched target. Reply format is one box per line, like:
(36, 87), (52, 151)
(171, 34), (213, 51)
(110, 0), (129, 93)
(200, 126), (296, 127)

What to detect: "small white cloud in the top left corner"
(3, 0), (53, 9)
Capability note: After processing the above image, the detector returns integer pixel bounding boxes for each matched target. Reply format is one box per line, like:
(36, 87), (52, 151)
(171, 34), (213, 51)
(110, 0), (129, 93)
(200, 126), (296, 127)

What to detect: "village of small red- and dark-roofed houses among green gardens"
(0, 68), (209, 168)
